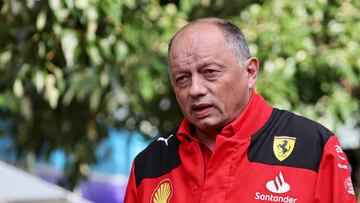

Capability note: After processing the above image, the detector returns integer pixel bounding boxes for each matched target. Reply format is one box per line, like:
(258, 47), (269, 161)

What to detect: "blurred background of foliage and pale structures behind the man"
(0, 0), (360, 203)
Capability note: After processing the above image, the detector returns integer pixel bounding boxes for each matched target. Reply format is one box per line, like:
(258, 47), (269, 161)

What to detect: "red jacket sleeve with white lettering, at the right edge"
(314, 136), (356, 203)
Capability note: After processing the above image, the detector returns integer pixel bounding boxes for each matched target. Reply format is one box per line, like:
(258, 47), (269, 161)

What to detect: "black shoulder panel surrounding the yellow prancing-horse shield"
(248, 109), (333, 172)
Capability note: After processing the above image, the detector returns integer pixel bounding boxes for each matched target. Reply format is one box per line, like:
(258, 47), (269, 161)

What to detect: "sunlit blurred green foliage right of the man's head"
(233, 0), (360, 129)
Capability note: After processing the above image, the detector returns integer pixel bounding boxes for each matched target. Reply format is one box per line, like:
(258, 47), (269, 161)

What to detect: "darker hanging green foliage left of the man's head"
(0, 0), (184, 188)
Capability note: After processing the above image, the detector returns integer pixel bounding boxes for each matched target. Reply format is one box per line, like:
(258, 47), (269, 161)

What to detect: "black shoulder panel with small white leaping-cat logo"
(134, 129), (180, 186)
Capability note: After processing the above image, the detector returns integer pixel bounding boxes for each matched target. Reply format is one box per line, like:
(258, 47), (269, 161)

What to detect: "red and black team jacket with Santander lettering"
(125, 93), (356, 203)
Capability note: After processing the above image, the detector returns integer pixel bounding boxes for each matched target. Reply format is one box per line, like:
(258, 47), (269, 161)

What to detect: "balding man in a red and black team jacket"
(125, 18), (355, 203)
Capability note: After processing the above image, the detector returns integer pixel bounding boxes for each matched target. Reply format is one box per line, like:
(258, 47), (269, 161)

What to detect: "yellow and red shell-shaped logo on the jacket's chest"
(150, 179), (172, 203)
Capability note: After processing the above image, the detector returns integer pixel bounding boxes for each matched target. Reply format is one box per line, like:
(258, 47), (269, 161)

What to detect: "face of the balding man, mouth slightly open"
(169, 24), (255, 131)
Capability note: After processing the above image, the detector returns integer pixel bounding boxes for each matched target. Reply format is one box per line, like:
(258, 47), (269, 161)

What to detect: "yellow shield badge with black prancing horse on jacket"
(273, 136), (296, 161)
